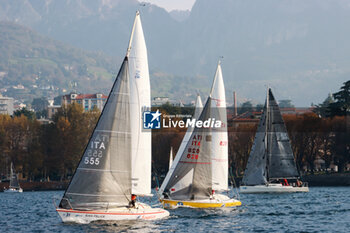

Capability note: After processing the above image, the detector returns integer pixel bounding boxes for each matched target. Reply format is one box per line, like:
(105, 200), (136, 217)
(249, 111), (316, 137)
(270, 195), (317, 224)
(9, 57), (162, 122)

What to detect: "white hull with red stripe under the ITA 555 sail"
(56, 203), (169, 223)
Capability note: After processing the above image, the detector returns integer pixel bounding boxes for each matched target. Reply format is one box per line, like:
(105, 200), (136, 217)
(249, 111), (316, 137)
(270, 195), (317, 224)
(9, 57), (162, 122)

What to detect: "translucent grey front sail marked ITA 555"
(60, 57), (131, 210)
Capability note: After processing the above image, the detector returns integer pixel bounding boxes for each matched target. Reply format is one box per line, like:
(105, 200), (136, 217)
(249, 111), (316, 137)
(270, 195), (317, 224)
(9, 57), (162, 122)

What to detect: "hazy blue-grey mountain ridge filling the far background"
(0, 0), (350, 106)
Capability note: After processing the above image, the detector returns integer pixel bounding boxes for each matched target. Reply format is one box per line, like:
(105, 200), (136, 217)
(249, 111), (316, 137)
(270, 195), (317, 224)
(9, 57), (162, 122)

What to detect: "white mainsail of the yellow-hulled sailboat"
(210, 62), (228, 191)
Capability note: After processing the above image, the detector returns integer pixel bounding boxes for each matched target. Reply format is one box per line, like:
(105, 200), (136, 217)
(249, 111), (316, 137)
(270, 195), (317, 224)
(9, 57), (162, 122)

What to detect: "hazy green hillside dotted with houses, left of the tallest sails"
(0, 22), (117, 103)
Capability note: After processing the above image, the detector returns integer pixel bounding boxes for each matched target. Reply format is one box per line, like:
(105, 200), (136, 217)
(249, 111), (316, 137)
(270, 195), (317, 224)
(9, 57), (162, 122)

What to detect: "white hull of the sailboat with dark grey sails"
(239, 184), (309, 193)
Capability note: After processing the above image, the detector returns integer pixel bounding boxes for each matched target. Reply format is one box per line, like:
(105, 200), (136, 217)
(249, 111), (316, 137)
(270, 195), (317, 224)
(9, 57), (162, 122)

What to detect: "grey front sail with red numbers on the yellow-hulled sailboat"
(164, 97), (212, 200)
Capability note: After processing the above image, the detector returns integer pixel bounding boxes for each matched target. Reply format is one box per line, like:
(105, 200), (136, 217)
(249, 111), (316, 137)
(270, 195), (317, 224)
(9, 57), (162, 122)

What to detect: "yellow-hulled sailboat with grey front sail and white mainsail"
(159, 62), (241, 208)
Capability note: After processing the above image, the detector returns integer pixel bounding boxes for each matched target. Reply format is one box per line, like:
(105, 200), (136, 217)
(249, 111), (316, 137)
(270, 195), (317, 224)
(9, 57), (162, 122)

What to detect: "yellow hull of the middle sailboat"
(160, 199), (242, 209)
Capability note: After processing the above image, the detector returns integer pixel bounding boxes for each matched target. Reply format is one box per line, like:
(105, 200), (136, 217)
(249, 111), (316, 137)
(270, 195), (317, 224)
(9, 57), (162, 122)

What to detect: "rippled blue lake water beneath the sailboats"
(0, 187), (350, 233)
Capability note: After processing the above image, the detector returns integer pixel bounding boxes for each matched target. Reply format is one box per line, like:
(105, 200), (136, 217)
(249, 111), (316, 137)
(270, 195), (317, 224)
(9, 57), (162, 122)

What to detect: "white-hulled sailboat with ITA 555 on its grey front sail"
(56, 12), (169, 223)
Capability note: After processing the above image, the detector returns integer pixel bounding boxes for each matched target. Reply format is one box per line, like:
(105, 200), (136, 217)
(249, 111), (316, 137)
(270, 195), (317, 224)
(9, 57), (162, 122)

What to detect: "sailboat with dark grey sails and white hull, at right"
(240, 88), (309, 193)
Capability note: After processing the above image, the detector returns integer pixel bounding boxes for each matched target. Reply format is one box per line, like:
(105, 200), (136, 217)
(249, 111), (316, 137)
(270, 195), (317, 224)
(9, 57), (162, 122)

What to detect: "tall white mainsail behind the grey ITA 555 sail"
(128, 12), (152, 195)
